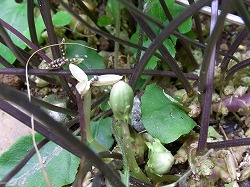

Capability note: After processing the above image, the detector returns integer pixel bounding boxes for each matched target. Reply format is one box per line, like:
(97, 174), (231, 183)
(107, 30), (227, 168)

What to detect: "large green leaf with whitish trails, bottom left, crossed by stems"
(0, 135), (80, 187)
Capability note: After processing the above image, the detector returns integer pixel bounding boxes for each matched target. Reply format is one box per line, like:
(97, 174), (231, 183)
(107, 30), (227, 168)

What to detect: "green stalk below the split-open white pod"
(83, 89), (108, 152)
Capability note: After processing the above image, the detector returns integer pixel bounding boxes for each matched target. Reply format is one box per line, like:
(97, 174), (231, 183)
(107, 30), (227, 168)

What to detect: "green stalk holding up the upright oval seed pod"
(120, 121), (150, 183)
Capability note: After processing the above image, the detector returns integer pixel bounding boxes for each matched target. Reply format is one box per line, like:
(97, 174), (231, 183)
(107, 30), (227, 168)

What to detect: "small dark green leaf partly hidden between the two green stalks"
(91, 118), (114, 149)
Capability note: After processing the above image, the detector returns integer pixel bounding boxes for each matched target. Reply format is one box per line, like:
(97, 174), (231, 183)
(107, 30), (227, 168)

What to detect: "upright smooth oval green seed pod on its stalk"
(110, 81), (134, 122)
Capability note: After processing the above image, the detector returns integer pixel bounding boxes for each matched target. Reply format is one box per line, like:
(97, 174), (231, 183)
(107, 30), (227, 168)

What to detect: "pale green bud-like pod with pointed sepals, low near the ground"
(146, 139), (174, 176)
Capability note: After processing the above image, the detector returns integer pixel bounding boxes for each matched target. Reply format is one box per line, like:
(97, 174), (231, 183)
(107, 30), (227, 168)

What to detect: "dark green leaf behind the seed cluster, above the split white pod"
(66, 40), (105, 69)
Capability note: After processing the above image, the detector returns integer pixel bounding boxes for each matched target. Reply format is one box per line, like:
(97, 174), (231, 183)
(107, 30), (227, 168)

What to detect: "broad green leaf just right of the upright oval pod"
(141, 84), (196, 143)
